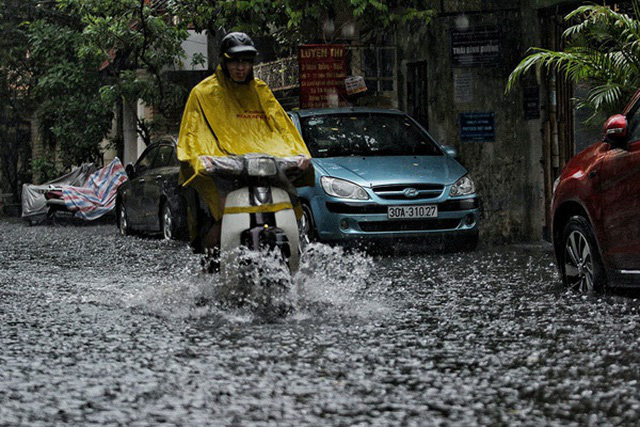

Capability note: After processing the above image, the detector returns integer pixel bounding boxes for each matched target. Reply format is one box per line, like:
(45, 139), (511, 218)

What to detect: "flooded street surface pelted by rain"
(0, 219), (640, 426)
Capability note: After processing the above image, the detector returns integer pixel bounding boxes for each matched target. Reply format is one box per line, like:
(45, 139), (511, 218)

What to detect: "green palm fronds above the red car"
(506, 0), (640, 117)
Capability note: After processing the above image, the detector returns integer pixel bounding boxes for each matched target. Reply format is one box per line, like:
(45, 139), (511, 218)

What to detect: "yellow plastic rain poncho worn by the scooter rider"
(178, 66), (311, 220)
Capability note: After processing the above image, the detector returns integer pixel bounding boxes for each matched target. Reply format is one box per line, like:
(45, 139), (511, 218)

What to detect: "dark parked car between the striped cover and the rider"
(116, 137), (186, 239)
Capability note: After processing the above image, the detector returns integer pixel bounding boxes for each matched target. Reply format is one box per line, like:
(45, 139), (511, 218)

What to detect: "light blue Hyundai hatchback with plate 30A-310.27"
(289, 108), (480, 250)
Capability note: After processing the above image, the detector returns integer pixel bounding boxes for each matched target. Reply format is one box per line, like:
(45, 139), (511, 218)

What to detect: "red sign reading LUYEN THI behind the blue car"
(298, 44), (348, 108)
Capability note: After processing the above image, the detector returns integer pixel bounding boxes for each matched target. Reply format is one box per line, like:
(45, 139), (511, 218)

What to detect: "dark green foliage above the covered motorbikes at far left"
(29, 17), (113, 169)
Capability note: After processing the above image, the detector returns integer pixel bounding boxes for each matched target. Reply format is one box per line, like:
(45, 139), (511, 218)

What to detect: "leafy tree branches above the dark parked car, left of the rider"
(57, 0), (188, 143)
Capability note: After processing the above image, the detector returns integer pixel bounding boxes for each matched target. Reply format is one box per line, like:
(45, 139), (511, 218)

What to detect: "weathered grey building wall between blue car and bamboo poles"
(397, 3), (544, 242)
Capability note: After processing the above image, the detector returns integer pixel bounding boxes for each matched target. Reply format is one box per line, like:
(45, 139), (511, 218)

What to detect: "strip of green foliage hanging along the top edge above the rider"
(175, 0), (433, 53)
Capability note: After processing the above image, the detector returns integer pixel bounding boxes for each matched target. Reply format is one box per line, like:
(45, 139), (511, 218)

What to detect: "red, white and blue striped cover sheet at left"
(62, 157), (127, 220)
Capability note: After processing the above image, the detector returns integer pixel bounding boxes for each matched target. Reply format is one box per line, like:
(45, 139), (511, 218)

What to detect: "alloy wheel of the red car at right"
(561, 216), (607, 293)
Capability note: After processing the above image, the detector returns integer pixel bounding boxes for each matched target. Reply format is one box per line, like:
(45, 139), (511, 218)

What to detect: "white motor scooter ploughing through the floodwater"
(200, 154), (311, 314)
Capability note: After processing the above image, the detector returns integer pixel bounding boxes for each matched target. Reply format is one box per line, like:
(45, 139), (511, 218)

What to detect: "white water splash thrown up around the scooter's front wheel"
(118, 243), (391, 323)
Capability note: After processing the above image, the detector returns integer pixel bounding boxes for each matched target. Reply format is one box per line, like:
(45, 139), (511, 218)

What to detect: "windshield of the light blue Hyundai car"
(301, 113), (442, 158)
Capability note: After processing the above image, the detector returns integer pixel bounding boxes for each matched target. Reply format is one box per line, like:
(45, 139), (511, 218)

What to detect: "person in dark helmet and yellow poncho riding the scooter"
(177, 32), (313, 260)
